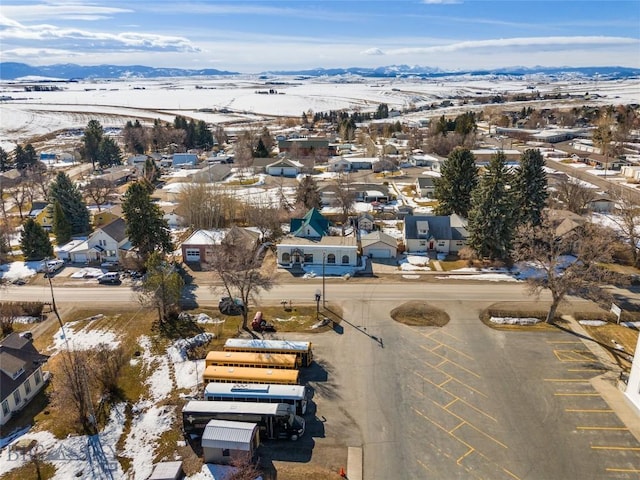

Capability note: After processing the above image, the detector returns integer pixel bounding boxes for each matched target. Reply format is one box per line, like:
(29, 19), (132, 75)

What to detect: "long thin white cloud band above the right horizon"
(385, 36), (640, 55)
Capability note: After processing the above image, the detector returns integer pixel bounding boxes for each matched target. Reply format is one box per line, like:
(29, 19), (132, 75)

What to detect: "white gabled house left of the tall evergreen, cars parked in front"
(69, 218), (131, 263)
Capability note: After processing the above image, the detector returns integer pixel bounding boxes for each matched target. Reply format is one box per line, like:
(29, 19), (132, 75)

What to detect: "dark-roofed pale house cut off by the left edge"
(0, 333), (49, 425)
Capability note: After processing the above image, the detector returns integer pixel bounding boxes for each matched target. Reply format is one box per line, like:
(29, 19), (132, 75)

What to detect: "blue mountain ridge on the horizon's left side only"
(0, 62), (238, 80)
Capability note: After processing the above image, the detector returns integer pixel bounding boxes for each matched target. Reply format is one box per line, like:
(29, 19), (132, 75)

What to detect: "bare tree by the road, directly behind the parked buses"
(212, 242), (274, 330)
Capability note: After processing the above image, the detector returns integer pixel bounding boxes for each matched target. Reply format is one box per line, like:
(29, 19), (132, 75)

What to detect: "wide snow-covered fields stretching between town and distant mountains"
(0, 73), (640, 149)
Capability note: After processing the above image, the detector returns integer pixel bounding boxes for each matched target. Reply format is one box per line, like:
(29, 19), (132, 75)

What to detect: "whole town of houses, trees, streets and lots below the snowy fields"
(0, 70), (640, 480)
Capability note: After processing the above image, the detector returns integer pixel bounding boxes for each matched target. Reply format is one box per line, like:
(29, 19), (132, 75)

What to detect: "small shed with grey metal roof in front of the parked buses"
(202, 420), (260, 464)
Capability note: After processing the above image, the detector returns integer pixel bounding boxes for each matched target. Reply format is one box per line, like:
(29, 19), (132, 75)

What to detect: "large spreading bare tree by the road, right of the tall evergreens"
(513, 215), (615, 323)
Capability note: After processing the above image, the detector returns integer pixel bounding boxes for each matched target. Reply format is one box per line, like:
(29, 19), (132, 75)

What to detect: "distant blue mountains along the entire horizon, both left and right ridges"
(0, 62), (640, 80)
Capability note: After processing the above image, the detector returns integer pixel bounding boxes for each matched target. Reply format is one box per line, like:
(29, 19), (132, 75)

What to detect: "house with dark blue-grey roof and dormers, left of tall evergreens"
(403, 214), (469, 254)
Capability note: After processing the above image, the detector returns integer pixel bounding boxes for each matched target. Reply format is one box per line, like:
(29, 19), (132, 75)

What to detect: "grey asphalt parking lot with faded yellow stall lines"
(304, 298), (640, 480)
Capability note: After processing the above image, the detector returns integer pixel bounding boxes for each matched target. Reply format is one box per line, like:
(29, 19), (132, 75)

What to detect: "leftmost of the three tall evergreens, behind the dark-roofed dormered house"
(434, 148), (478, 218)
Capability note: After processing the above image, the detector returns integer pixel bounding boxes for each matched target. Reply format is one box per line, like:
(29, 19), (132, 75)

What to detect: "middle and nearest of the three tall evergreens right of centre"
(468, 152), (515, 260)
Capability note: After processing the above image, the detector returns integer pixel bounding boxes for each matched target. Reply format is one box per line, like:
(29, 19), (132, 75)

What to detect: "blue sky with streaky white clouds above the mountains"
(0, 0), (640, 73)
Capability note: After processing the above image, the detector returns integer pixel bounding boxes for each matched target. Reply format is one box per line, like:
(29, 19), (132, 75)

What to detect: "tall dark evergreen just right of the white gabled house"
(122, 182), (173, 261)
